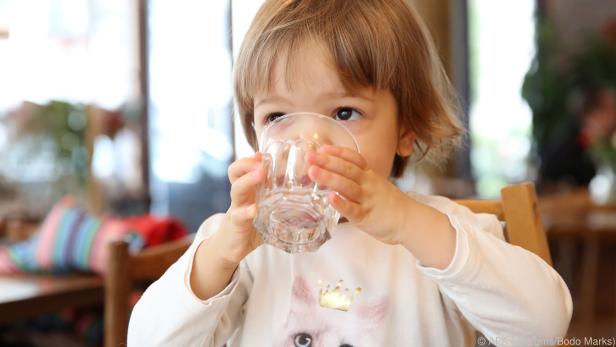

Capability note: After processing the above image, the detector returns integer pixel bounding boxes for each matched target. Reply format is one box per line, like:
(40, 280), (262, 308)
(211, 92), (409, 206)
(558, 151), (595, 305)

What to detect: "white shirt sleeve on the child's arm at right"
(417, 196), (573, 346)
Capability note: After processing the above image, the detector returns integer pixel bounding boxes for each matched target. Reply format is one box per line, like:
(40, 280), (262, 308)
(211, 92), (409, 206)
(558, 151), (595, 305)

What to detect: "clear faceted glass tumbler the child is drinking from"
(254, 112), (359, 253)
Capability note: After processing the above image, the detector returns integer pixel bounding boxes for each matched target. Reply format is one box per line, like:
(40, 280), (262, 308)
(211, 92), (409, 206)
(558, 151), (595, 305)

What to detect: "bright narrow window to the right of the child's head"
(469, 0), (535, 197)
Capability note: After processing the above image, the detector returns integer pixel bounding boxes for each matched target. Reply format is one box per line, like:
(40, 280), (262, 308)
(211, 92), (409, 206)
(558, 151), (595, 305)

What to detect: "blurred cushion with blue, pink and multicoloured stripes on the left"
(0, 197), (143, 274)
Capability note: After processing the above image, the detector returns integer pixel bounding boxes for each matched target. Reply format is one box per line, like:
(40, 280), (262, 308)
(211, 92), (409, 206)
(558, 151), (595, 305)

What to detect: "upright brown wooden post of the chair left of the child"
(104, 241), (131, 347)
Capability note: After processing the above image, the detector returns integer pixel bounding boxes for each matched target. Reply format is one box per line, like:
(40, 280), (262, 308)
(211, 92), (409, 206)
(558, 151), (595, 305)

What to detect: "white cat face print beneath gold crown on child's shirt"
(274, 276), (389, 347)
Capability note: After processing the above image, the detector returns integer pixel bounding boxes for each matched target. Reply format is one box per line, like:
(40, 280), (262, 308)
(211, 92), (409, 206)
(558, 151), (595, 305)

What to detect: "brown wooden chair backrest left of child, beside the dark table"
(104, 237), (192, 347)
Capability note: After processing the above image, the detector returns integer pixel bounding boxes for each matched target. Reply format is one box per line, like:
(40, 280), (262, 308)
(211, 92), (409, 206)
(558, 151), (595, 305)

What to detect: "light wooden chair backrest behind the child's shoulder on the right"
(457, 183), (552, 265)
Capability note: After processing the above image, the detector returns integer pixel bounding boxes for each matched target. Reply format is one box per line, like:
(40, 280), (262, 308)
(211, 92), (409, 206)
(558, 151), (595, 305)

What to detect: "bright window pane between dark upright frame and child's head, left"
(148, 0), (233, 231)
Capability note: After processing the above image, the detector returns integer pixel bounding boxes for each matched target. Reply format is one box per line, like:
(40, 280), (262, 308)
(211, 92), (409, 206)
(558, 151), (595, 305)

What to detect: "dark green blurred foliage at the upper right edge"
(522, 16), (616, 162)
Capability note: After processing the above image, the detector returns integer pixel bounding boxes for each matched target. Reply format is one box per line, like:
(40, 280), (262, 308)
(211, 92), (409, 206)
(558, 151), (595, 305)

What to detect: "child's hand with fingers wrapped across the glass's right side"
(306, 146), (410, 244)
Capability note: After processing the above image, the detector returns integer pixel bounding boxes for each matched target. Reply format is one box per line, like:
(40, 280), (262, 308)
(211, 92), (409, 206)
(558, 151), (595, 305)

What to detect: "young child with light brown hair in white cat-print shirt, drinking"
(128, 0), (572, 347)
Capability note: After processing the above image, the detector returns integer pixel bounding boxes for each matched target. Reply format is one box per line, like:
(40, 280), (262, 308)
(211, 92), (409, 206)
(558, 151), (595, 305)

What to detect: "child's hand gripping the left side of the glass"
(218, 153), (265, 267)
